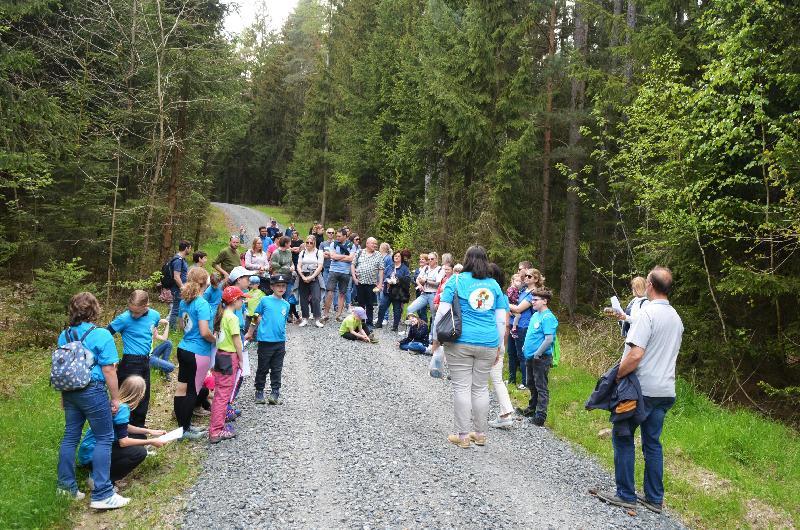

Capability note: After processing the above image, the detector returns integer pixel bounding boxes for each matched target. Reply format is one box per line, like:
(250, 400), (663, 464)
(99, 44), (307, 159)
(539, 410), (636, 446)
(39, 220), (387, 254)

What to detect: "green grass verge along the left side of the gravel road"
(0, 201), (230, 528)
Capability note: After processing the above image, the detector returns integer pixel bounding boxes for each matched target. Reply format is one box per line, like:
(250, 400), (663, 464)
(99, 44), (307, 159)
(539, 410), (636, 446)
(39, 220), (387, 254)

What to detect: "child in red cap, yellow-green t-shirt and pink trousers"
(208, 286), (248, 444)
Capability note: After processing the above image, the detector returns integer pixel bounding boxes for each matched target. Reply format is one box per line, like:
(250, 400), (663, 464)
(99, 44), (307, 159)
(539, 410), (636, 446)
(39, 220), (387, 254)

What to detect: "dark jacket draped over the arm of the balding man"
(584, 363), (647, 436)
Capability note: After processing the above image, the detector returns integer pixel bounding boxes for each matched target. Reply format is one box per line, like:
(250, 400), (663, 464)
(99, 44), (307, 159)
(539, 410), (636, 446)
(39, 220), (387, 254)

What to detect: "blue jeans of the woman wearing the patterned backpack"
(58, 381), (114, 501)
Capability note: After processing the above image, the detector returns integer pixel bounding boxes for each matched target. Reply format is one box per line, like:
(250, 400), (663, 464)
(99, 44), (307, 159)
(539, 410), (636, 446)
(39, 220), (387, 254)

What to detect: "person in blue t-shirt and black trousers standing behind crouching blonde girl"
(107, 289), (161, 437)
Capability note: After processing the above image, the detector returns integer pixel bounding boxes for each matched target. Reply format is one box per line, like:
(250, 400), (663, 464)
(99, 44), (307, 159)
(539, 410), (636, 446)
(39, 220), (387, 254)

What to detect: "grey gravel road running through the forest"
(183, 203), (682, 529)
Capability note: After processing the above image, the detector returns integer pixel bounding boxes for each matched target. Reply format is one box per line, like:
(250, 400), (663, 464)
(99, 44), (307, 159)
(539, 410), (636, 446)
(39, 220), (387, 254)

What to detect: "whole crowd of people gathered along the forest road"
(53, 216), (682, 509)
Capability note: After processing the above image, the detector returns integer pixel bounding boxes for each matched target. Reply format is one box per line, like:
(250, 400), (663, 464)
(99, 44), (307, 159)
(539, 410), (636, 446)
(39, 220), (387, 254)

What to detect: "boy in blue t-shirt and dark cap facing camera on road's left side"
(245, 274), (289, 405)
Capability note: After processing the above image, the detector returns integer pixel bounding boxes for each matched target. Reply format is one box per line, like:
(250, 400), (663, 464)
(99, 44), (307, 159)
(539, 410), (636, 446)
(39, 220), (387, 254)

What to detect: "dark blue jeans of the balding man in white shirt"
(611, 396), (675, 504)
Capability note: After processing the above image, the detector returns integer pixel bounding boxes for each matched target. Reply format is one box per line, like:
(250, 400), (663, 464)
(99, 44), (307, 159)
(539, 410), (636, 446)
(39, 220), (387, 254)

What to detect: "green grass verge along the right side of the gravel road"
(510, 325), (800, 528)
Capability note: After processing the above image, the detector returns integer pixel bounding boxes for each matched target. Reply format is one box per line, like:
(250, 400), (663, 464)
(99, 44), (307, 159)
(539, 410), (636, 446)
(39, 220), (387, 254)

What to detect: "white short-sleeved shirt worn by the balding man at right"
(622, 300), (683, 397)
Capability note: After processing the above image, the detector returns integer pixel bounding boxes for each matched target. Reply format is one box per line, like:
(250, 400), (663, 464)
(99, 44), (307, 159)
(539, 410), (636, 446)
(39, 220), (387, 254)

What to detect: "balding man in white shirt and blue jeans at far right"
(597, 267), (683, 513)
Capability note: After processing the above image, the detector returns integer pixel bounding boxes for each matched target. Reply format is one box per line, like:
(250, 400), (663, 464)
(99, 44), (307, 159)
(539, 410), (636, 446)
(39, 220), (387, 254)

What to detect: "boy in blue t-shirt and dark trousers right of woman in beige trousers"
(522, 289), (558, 427)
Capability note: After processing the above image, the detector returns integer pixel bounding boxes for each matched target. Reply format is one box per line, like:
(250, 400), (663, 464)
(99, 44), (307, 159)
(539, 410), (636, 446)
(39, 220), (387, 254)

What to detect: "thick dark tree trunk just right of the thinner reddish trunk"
(561, 2), (588, 316)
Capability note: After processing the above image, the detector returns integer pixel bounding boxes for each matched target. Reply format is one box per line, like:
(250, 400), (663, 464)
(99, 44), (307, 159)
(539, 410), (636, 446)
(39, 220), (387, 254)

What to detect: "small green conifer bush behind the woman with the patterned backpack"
(24, 258), (96, 340)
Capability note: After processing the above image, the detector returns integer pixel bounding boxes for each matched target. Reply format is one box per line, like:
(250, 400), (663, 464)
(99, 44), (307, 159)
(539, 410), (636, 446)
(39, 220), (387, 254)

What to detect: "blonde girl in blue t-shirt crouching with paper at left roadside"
(78, 375), (167, 485)
